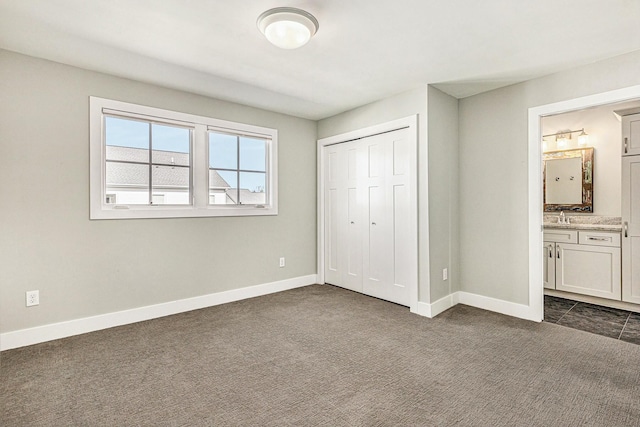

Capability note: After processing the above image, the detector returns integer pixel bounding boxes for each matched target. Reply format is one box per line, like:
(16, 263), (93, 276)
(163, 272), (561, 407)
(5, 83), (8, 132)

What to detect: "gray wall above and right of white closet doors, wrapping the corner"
(318, 86), (458, 302)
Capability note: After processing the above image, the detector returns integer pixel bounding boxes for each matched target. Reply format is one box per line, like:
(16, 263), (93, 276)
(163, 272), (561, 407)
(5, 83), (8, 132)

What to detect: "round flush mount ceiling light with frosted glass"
(258, 7), (318, 49)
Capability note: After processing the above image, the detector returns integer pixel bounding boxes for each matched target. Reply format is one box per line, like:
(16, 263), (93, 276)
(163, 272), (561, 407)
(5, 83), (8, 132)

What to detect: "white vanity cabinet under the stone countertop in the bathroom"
(544, 229), (622, 301)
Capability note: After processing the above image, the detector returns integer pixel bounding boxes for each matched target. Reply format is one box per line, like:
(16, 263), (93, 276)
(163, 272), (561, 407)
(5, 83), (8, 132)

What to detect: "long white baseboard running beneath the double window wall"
(0, 274), (317, 351)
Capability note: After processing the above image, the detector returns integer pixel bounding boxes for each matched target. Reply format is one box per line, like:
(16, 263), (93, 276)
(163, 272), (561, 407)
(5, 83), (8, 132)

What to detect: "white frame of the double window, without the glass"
(89, 96), (278, 219)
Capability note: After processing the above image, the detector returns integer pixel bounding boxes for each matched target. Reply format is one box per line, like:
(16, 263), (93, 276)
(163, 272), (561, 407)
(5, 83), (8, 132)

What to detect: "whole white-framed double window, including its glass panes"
(90, 97), (278, 219)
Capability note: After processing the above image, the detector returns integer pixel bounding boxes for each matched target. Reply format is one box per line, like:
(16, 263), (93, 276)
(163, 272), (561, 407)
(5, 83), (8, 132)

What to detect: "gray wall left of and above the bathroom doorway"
(459, 51), (640, 304)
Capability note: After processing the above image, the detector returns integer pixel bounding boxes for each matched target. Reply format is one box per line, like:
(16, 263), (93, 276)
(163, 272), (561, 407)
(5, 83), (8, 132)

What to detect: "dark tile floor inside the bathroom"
(544, 295), (640, 344)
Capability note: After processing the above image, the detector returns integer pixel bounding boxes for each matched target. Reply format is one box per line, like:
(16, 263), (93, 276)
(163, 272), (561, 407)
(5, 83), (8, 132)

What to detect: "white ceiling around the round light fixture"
(0, 0), (640, 120)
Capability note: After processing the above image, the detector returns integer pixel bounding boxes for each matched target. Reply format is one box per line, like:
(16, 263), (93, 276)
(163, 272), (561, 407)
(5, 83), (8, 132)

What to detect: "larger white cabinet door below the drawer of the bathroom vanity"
(556, 243), (621, 301)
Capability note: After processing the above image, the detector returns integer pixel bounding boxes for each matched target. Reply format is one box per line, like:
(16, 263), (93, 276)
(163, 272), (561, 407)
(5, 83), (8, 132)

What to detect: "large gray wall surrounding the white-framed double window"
(0, 51), (317, 332)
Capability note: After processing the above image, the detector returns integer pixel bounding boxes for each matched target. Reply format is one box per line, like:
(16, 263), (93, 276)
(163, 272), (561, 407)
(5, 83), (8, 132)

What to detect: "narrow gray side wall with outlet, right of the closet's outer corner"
(427, 86), (459, 302)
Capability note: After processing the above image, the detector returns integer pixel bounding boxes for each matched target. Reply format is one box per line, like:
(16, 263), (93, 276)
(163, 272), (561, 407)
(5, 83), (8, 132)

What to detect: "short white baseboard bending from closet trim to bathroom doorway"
(416, 292), (541, 322)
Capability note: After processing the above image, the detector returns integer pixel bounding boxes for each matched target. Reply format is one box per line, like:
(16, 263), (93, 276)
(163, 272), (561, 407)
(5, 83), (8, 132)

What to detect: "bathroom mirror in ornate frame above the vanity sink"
(542, 147), (593, 212)
